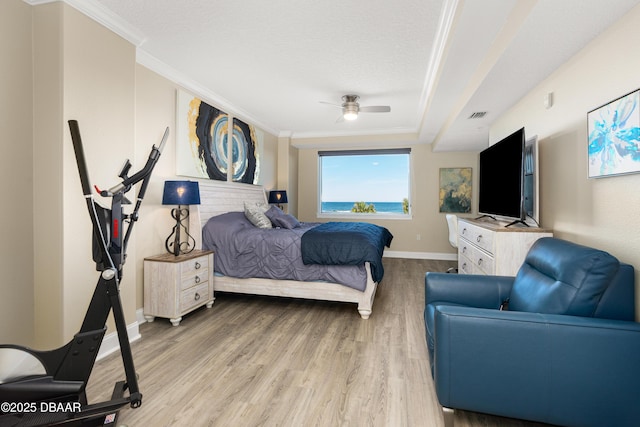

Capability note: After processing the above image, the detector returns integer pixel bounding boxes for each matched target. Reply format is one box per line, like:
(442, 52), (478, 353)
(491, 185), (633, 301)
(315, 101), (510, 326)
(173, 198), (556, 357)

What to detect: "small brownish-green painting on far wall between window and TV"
(439, 168), (471, 213)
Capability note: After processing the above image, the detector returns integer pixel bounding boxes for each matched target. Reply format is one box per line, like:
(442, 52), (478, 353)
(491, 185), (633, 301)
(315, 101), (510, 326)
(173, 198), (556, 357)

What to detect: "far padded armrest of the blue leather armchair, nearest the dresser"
(424, 272), (515, 309)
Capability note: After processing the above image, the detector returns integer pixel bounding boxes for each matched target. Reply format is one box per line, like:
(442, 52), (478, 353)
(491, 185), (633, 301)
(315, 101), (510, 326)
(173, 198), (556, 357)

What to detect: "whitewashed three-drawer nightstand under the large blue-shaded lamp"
(144, 250), (215, 326)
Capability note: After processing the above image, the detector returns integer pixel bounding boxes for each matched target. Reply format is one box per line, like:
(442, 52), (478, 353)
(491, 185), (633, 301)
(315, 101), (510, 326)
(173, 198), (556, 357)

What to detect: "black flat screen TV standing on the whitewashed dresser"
(478, 128), (527, 225)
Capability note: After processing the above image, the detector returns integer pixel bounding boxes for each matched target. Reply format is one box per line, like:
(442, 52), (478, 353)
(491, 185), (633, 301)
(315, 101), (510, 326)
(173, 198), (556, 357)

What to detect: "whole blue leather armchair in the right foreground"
(424, 238), (640, 427)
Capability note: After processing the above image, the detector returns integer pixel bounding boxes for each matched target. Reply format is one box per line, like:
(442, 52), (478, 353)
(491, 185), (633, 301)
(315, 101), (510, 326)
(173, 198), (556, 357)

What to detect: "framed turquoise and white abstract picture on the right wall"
(587, 89), (640, 178)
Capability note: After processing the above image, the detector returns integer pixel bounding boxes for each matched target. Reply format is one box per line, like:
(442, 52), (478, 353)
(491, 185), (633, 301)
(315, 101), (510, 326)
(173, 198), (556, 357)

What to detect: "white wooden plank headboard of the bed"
(189, 180), (267, 249)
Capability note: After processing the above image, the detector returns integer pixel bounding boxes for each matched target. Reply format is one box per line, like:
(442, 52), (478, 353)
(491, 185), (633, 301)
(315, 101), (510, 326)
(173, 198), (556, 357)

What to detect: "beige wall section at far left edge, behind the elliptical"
(0, 0), (34, 345)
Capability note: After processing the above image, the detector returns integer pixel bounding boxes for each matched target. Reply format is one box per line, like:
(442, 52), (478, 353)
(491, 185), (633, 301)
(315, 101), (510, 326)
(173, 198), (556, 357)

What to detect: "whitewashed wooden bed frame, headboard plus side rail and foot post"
(189, 181), (378, 319)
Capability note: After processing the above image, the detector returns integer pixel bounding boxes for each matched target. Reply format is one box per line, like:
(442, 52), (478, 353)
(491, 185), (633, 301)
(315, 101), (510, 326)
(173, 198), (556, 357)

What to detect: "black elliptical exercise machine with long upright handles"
(0, 120), (169, 427)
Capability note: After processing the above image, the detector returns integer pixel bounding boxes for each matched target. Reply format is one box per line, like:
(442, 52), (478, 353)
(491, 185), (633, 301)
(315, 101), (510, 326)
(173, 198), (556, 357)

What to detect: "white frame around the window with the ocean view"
(316, 147), (413, 220)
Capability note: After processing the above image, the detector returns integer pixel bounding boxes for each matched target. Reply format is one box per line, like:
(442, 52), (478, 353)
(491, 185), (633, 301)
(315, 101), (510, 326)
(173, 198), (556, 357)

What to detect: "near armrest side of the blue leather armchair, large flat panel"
(434, 306), (640, 426)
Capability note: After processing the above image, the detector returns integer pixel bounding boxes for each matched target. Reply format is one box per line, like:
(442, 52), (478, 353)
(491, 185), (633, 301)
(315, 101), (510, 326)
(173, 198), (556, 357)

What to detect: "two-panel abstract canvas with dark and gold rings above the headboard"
(176, 90), (264, 184)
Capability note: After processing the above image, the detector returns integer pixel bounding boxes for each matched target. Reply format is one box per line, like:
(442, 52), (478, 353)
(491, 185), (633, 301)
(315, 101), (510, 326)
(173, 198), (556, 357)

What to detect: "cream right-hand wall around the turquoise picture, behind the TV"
(490, 6), (640, 318)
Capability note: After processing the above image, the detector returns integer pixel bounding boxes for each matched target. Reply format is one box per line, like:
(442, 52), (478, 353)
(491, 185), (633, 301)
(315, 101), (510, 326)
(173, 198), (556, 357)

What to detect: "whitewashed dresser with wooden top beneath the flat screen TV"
(458, 219), (553, 276)
